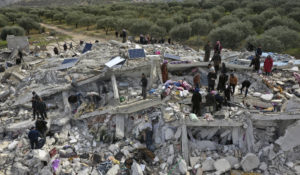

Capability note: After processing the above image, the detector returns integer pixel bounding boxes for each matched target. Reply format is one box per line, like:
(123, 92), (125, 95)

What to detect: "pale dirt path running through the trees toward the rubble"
(40, 23), (105, 43)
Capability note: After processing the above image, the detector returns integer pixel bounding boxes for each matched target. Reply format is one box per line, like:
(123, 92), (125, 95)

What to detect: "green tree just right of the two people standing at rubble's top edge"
(129, 20), (153, 36)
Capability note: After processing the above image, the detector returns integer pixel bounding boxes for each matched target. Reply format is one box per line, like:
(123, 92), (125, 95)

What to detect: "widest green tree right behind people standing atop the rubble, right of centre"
(209, 22), (253, 48)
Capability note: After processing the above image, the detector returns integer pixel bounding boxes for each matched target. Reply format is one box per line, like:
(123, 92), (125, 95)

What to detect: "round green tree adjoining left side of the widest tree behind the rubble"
(191, 19), (213, 35)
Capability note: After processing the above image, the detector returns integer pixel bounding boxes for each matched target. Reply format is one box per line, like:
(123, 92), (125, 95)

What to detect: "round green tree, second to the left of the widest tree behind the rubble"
(170, 24), (192, 41)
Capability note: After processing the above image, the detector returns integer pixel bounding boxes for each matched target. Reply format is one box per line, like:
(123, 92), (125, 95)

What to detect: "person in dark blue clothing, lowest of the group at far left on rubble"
(28, 127), (46, 149)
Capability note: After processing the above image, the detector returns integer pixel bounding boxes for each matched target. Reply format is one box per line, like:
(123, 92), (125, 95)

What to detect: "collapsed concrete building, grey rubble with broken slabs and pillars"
(0, 37), (300, 175)
